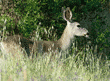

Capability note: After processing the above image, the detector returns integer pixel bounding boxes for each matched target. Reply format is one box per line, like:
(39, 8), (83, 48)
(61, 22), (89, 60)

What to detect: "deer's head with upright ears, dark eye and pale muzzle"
(62, 7), (88, 38)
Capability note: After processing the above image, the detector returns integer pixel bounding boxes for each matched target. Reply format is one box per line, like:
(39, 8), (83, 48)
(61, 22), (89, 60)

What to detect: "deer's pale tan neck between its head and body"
(58, 27), (74, 50)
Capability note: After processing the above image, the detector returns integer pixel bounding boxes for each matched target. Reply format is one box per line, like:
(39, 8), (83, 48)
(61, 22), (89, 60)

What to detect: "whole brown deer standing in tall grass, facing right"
(0, 7), (89, 56)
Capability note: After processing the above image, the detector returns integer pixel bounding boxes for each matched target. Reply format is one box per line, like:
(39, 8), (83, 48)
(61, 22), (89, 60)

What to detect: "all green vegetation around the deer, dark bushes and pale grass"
(0, 0), (110, 81)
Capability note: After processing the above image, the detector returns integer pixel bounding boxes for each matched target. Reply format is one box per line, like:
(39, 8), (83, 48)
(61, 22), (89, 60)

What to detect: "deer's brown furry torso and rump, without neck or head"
(2, 35), (61, 56)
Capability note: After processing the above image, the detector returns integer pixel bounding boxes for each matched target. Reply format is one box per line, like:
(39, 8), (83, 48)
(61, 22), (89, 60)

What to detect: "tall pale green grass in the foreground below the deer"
(0, 49), (110, 81)
